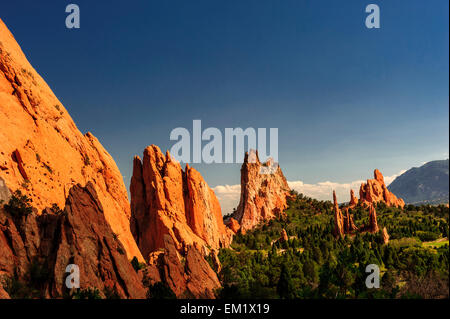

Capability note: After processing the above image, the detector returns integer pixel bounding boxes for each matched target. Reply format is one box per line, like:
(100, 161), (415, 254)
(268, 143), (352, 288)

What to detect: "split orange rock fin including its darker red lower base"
(130, 145), (233, 298)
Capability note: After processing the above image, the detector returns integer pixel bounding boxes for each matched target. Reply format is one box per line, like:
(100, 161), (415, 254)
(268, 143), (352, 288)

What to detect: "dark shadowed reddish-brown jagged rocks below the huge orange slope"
(0, 183), (145, 298)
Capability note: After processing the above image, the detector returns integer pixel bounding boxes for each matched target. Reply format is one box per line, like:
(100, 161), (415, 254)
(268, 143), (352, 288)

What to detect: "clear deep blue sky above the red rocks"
(0, 0), (449, 212)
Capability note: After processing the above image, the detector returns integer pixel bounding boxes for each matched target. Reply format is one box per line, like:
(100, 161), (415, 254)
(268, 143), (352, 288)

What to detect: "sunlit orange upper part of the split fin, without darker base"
(130, 145), (232, 258)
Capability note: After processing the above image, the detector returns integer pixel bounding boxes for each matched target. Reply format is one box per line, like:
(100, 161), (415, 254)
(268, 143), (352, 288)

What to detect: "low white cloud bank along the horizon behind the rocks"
(213, 170), (406, 215)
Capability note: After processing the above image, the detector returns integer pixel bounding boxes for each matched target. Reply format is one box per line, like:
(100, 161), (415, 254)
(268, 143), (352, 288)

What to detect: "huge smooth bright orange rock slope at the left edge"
(0, 20), (142, 260)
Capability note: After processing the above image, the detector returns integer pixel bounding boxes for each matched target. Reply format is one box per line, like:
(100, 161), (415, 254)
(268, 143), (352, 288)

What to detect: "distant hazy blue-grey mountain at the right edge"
(388, 159), (449, 204)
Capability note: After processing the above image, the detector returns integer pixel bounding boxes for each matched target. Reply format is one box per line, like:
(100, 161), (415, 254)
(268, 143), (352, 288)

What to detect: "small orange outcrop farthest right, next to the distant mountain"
(359, 169), (405, 208)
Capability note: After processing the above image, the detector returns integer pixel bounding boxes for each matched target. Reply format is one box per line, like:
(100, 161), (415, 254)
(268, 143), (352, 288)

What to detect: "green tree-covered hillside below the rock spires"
(218, 194), (449, 298)
